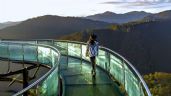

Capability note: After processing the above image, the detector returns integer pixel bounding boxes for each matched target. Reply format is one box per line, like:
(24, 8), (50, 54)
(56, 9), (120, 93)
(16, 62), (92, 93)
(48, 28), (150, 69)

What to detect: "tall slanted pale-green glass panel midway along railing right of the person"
(110, 54), (124, 84)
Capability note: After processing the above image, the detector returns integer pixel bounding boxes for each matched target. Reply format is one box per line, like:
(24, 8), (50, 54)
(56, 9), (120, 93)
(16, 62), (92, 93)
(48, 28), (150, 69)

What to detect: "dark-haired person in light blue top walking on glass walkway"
(86, 34), (99, 76)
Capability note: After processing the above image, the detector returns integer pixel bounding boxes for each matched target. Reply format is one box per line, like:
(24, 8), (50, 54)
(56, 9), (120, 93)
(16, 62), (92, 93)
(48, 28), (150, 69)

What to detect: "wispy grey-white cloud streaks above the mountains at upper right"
(101, 0), (171, 8)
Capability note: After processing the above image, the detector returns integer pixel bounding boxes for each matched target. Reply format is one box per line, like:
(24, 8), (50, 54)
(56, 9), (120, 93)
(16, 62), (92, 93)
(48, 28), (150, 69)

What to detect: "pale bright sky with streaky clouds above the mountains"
(0, 0), (171, 22)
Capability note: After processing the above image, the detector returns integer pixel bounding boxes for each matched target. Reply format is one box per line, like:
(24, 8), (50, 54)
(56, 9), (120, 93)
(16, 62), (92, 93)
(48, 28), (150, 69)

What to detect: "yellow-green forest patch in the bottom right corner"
(144, 72), (171, 96)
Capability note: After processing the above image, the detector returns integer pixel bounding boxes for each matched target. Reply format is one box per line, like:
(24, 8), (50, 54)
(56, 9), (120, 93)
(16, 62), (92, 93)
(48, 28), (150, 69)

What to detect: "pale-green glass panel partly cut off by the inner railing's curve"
(54, 42), (68, 55)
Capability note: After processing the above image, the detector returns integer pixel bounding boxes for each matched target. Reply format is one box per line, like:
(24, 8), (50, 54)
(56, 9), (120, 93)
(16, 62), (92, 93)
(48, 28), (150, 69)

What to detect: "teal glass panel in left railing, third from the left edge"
(23, 45), (38, 62)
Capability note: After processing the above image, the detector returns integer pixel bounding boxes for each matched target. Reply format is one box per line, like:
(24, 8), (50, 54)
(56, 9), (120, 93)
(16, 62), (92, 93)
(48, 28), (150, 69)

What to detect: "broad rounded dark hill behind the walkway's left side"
(0, 15), (110, 39)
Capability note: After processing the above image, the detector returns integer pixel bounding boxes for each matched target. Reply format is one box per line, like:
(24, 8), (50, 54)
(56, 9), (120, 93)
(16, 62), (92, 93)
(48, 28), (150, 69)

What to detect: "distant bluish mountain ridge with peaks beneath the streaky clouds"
(85, 11), (151, 24)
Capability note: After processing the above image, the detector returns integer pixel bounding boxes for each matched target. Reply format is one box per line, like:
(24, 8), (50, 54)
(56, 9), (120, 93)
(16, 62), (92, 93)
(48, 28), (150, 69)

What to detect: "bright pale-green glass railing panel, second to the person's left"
(68, 43), (81, 58)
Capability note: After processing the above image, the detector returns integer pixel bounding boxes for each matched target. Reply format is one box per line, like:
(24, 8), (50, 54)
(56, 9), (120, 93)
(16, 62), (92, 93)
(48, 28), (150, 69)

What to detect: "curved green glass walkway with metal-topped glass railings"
(0, 40), (151, 96)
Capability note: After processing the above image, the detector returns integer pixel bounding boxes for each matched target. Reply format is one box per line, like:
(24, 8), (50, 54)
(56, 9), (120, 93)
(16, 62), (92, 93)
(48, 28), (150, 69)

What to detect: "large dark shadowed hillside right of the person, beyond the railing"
(59, 21), (171, 73)
